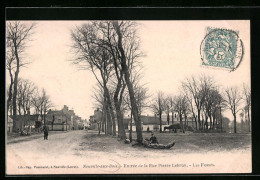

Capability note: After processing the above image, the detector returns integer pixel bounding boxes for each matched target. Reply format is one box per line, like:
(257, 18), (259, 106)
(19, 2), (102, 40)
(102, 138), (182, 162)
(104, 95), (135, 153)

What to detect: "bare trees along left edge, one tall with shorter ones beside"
(6, 21), (52, 129)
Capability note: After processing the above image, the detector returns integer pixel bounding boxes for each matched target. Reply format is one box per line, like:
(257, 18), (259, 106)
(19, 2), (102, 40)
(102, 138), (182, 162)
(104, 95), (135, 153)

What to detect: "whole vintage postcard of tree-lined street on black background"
(6, 20), (252, 175)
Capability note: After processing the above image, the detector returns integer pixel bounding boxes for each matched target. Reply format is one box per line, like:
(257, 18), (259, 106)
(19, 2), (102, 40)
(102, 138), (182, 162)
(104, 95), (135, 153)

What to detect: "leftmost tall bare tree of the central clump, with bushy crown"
(71, 23), (116, 135)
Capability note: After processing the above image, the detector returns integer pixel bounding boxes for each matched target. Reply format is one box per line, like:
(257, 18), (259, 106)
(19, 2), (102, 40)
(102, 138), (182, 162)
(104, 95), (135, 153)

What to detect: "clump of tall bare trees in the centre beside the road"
(71, 21), (146, 143)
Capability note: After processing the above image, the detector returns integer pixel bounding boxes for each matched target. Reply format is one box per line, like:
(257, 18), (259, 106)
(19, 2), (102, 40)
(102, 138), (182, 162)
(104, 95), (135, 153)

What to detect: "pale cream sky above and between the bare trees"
(6, 20), (250, 119)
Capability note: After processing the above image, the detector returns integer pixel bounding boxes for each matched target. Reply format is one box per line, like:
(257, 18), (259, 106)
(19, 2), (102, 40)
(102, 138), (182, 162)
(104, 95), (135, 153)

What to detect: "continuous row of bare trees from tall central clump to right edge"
(71, 21), (251, 143)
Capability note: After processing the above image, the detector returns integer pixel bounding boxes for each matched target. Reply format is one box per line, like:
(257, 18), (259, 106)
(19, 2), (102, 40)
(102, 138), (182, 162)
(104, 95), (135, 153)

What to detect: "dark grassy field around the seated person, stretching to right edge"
(86, 132), (251, 153)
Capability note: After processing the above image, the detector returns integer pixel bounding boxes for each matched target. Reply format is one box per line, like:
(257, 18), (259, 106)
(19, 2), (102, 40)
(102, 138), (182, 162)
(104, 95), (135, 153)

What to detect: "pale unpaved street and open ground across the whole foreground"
(6, 131), (251, 174)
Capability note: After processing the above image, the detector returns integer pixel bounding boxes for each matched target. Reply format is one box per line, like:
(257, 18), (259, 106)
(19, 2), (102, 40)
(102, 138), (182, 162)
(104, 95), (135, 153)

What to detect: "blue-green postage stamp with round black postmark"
(200, 27), (244, 71)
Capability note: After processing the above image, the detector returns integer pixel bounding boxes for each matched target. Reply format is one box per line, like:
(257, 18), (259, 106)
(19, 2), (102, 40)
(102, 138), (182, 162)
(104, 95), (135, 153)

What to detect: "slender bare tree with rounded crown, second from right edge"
(225, 87), (242, 133)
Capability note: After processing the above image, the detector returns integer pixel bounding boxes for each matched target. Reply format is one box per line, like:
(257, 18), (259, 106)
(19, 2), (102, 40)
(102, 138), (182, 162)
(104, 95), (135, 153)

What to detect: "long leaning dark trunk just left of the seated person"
(114, 21), (143, 144)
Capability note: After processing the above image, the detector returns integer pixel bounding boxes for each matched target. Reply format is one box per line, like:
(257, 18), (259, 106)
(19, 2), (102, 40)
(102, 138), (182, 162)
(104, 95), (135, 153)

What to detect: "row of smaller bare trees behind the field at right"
(152, 74), (251, 133)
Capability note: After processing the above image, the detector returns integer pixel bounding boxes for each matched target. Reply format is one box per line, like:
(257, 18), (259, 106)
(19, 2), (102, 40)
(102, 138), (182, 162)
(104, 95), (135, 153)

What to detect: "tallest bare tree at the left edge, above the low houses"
(6, 22), (35, 118)
